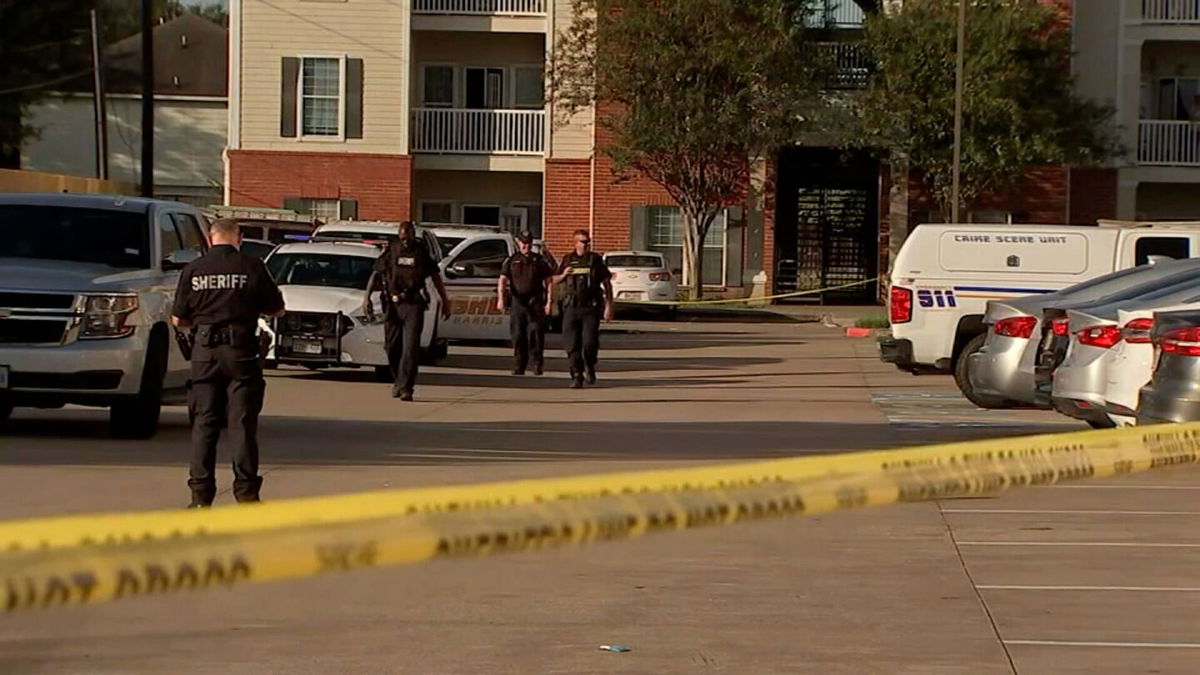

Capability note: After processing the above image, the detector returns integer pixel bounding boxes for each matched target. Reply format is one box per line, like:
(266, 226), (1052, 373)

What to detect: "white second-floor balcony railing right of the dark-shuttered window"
(413, 108), (546, 155)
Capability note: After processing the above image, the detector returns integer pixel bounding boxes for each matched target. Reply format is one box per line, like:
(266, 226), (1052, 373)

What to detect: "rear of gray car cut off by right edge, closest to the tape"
(1138, 310), (1200, 424)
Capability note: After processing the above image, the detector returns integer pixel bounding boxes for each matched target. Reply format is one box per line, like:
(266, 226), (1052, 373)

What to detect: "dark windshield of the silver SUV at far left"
(0, 204), (150, 269)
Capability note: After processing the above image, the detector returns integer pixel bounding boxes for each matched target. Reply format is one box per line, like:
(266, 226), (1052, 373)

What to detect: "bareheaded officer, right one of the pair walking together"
(553, 229), (612, 389)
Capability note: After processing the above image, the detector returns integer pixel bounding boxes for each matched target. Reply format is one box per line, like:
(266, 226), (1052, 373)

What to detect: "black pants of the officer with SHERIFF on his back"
(187, 345), (266, 504)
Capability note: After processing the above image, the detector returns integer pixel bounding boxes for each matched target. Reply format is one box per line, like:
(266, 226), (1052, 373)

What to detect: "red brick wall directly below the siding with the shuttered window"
(229, 150), (413, 220)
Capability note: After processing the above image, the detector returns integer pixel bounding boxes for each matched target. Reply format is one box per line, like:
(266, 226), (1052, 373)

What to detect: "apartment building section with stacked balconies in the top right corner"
(1074, 0), (1200, 220)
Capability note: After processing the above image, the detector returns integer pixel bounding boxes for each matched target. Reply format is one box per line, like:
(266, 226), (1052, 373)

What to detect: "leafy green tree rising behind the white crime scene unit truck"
(851, 0), (1120, 220)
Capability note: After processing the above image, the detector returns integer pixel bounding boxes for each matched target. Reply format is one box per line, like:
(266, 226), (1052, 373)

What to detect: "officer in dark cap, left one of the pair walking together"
(496, 231), (554, 375)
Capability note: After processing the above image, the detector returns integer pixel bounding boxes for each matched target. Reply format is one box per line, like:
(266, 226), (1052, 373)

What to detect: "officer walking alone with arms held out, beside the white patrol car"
(362, 221), (450, 401)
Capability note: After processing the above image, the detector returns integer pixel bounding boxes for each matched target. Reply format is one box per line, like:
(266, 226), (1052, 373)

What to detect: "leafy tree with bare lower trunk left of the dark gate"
(550, 0), (822, 298)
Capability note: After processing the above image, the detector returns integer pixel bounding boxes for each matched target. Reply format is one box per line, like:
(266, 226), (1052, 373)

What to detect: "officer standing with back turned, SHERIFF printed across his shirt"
(172, 219), (283, 508)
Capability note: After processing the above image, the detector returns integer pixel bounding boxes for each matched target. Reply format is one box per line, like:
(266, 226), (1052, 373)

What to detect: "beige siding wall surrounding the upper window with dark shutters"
(232, 0), (410, 154)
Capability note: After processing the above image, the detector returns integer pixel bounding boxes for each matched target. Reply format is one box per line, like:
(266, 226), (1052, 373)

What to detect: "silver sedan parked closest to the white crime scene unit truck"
(964, 259), (1200, 408)
